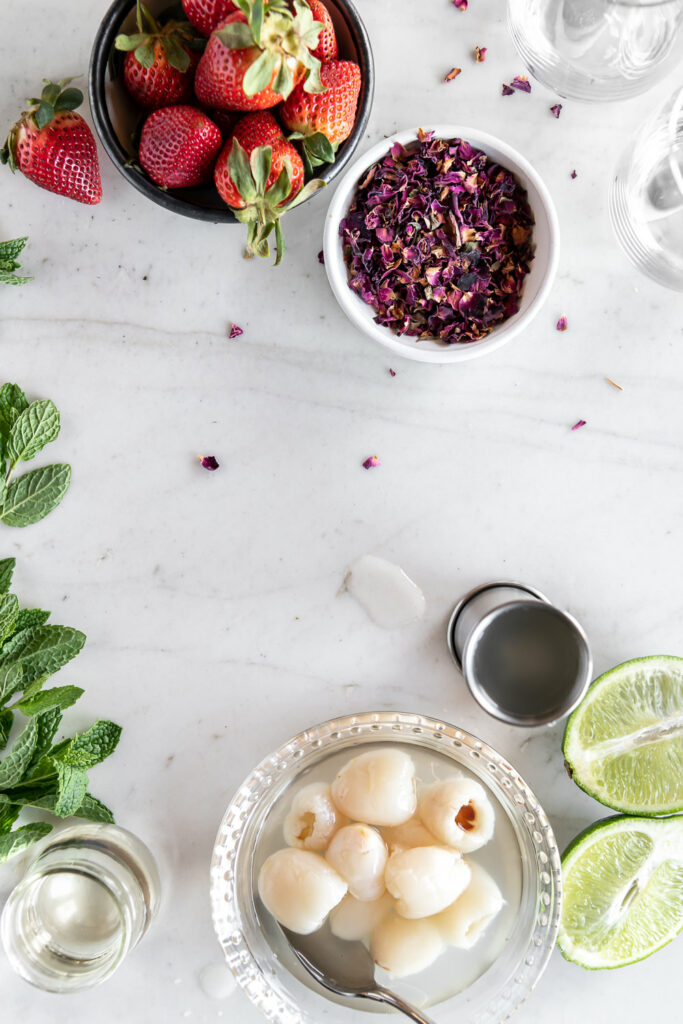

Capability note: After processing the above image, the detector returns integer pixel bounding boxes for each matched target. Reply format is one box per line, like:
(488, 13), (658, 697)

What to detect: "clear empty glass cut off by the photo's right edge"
(609, 84), (683, 291)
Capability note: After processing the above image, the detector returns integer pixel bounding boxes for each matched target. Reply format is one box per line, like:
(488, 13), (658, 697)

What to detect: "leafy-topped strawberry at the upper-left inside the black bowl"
(115, 0), (200, 111)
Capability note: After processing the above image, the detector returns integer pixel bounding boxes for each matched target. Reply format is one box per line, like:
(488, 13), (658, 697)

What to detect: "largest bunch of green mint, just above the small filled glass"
(0, 558), (121, 863)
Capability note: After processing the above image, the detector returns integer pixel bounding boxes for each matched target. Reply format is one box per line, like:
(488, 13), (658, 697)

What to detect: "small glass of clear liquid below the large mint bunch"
(0, 824), (161, 992)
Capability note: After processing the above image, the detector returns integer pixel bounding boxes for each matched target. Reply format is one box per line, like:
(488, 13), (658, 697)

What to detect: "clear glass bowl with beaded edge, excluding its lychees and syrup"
(211, 712), (561, 1024)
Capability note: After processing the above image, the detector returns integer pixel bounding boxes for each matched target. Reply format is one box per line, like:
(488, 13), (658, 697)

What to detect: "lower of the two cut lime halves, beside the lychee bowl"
(557, 815), (683, 971)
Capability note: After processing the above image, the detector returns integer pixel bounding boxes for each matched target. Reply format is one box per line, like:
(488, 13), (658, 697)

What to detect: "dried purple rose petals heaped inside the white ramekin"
(339, 131), (533, 344)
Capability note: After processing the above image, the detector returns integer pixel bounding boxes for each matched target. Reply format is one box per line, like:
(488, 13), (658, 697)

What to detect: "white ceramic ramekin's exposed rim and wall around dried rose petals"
(324, 125), (560, 362)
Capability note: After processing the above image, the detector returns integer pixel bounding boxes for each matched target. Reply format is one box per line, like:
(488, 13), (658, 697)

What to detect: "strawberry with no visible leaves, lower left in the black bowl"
(139, 106), (222, 188)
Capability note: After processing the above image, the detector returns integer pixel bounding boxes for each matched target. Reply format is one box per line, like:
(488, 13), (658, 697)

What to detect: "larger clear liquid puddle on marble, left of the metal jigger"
(343, 555), (426, 630)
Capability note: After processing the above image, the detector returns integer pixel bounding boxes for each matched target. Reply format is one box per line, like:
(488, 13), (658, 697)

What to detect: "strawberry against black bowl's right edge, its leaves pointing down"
(280, 60), (360, 167)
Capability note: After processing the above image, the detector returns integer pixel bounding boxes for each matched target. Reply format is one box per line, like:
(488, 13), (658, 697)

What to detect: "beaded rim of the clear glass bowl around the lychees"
(210, 712), (562, 1024)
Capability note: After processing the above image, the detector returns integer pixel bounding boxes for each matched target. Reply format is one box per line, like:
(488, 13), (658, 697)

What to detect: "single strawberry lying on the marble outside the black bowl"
(0, 78), (102, 206)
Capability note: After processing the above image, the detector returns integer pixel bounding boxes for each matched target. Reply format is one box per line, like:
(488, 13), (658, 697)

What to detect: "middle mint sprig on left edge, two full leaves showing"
(0, 384), (71, 526)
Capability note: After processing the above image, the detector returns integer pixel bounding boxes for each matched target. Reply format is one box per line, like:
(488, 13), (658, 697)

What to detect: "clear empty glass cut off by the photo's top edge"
(508, 0), (683, 101)
